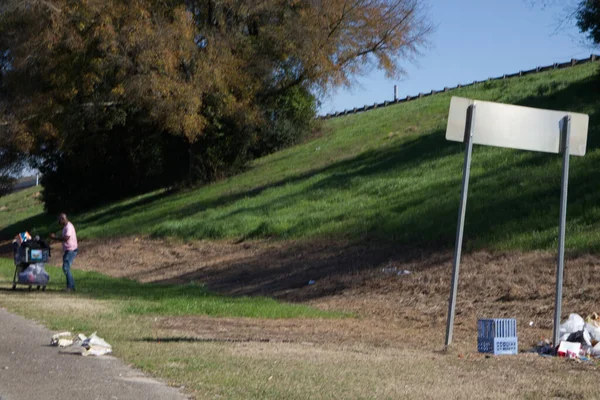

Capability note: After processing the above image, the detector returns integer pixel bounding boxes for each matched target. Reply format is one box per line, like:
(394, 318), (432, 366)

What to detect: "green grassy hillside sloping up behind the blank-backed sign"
(0, 64), (600, 252)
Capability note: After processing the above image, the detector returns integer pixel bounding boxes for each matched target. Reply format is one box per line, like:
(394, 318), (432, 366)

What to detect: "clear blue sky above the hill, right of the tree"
(320, 0), (594, 114)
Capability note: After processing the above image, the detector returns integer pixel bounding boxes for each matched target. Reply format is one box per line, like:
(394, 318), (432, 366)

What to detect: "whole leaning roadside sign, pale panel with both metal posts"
(446, 97), (589, 346)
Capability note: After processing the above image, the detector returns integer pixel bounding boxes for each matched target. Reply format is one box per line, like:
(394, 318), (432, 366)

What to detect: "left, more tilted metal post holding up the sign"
(446, 104), (475, 346)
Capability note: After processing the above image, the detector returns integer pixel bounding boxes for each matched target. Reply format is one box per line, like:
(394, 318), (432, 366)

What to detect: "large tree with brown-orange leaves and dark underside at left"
(0, 0), (431, 208)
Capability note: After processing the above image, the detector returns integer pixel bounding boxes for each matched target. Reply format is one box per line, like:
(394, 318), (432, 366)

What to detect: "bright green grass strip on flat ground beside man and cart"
(0, 259), (345, 318)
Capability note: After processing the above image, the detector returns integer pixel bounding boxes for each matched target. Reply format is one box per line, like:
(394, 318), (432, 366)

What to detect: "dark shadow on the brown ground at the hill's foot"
(149, 240), (451, 302)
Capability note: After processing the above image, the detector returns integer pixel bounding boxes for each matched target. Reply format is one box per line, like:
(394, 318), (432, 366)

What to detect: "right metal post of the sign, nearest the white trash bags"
(552, 116), (571, 347)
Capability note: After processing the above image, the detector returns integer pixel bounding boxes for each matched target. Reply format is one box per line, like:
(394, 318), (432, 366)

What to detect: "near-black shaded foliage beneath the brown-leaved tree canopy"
(38, 116), (187, 213)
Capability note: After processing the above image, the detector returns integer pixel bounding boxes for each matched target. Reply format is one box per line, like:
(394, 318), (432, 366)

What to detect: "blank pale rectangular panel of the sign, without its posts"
(446, 97), (589, 156)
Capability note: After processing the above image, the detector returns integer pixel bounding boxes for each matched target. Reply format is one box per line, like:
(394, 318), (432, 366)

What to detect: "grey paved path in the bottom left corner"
(0, 308), (186, 400)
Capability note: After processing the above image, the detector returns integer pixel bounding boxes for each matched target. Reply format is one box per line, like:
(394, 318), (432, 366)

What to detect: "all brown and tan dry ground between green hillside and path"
(0, 238), (600, 399)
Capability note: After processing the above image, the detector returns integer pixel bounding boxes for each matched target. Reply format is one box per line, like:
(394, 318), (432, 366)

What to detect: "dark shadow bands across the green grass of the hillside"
(0, 66), (600, 251)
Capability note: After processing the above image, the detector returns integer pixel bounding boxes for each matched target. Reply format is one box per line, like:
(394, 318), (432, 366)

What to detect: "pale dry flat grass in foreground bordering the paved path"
(0, 291), (600, 399)
